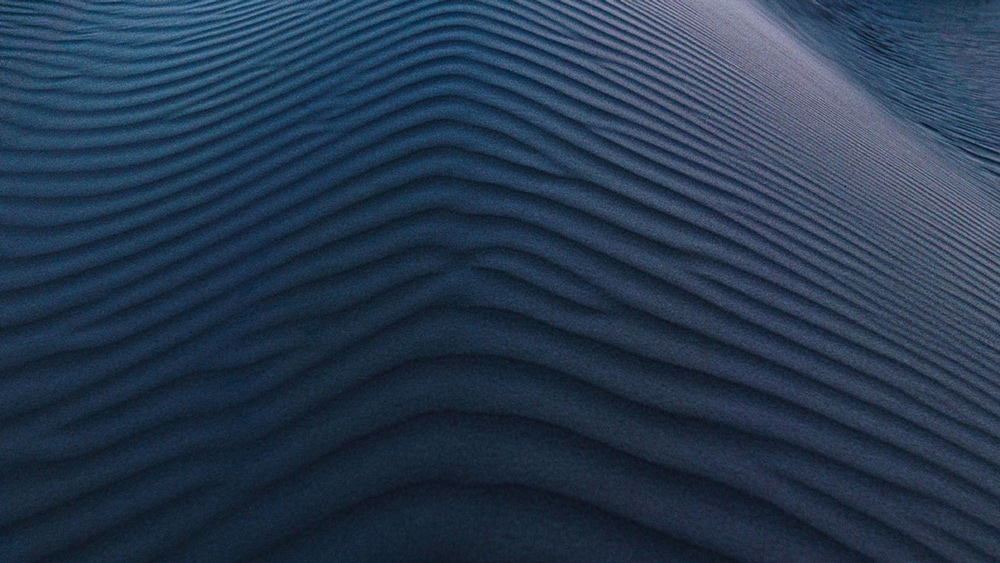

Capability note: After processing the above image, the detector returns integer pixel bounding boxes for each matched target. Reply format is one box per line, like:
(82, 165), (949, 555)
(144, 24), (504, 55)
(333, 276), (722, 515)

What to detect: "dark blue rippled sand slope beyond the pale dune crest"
(765, 0), (1000, 178)
